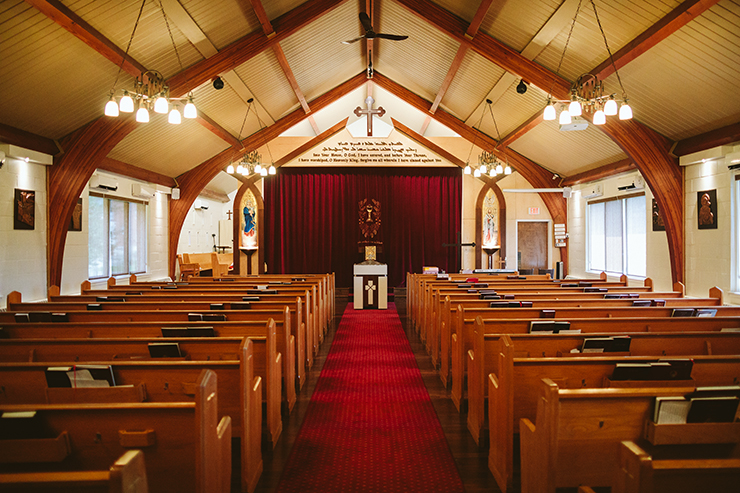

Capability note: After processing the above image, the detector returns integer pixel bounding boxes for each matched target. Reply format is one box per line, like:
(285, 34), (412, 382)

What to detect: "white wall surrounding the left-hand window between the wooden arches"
(61, 170), (169, 294)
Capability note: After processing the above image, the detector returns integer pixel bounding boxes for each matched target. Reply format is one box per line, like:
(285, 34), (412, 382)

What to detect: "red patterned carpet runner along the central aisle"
(277, 303), (463, 493)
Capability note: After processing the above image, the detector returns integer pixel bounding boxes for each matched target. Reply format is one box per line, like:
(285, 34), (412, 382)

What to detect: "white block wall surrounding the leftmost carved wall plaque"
(0, 157), (47, 308)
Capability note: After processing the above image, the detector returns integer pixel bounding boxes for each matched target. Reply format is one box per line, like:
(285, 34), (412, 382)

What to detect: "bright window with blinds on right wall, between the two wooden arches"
(587, 193), (647, 277)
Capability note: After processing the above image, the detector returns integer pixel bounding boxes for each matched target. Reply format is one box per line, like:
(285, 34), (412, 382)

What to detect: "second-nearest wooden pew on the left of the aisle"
(0, 371), (231, 493)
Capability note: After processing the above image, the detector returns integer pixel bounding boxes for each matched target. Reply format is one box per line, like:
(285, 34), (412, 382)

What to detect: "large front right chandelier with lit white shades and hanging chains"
(543, 0), (632, 125)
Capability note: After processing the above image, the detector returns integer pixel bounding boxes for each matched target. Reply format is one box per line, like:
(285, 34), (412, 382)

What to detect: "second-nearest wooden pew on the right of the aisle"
(520, 378), (740, 493)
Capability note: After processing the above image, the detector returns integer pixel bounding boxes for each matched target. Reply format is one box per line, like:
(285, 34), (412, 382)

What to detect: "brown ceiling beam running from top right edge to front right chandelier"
(591, 0), (719, 80)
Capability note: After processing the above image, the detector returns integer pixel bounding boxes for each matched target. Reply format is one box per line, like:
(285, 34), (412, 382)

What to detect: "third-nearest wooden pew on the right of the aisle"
(487, 344), (740, 491)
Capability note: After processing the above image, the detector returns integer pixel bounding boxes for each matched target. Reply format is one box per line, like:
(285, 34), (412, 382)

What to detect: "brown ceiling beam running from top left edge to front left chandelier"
(26, 0), (146, 77)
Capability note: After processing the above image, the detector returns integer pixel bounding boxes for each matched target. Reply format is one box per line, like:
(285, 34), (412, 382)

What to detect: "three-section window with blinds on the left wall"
(88, 193), (148, 279)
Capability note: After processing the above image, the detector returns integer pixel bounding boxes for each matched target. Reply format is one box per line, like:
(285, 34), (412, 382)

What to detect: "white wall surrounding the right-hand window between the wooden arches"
(568, 172), (676, 290)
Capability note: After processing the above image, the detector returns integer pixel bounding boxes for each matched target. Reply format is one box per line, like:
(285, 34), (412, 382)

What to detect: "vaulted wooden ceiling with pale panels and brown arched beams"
(0, 0), (740, 282)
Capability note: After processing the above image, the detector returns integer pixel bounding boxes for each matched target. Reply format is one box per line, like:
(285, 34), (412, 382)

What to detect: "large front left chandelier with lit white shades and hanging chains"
(105, 0), (198, 125)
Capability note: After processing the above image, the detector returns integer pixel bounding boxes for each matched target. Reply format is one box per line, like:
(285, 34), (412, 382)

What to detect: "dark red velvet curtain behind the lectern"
(264, 167), (462, 287)
